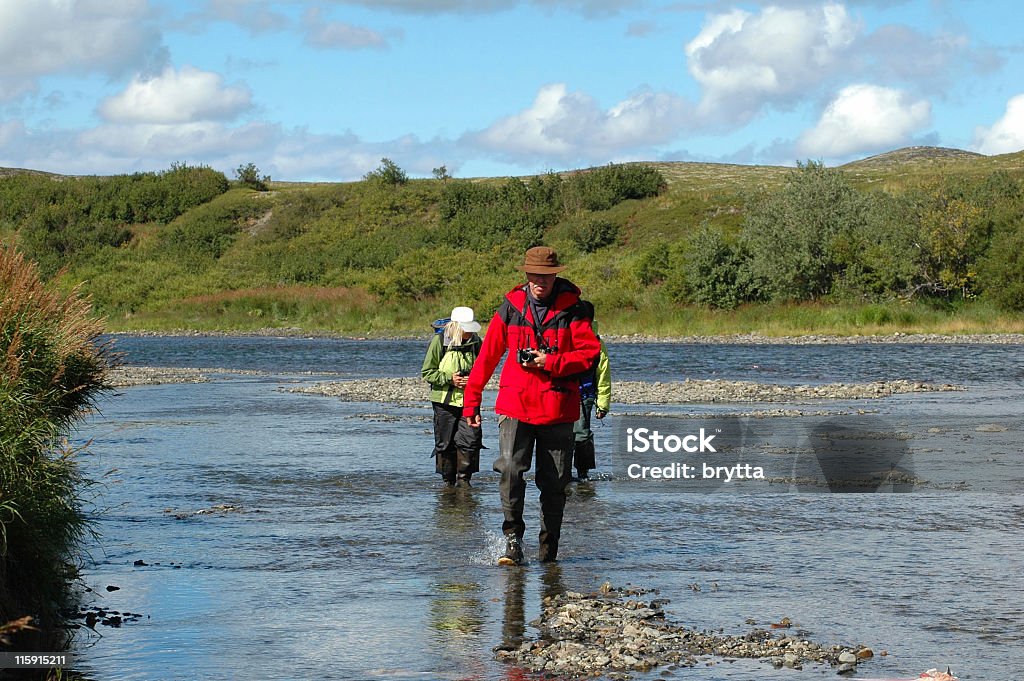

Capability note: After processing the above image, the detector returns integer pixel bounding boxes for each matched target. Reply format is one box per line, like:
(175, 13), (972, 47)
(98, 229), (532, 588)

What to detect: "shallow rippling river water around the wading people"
(68, 338), (1024, 679)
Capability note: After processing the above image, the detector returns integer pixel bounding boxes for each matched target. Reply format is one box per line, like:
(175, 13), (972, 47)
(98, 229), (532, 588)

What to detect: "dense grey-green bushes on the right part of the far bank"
(671, 162), (1024, 309)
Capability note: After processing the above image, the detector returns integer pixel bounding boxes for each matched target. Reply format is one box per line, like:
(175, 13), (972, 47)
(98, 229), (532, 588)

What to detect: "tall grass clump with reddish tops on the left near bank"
(0, 247), (113, 643)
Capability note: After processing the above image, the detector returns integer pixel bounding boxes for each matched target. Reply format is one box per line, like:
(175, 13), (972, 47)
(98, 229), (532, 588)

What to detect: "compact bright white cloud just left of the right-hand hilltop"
(797, 84), (932, 159)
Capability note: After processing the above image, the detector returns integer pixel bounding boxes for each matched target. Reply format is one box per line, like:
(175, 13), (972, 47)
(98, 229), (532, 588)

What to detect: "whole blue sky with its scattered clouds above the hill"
(0, 0), (1024, 180)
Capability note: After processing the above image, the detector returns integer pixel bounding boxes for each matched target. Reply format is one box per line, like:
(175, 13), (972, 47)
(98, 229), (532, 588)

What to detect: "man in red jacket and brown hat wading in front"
(463, 246), (601, 565)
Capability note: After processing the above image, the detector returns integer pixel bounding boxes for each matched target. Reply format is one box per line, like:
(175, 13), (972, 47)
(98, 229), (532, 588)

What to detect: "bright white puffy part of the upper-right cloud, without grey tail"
(686, 3), (861, 124)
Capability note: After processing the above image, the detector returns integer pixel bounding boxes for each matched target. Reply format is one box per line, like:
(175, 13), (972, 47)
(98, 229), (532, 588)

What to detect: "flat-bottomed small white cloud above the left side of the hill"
(99, 67), (252, 124)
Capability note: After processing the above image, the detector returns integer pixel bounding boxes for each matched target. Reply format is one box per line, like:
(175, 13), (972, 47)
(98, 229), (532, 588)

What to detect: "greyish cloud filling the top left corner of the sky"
(0, 0), (167, 101)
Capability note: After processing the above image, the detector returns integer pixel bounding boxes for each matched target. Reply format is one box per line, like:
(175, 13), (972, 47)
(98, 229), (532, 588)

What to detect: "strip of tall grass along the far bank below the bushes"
(109, 292), (1024, 338)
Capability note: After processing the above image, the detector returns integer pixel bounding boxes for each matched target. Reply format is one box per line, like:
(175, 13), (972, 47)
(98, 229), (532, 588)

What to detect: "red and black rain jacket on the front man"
(463, 278), (601, 425)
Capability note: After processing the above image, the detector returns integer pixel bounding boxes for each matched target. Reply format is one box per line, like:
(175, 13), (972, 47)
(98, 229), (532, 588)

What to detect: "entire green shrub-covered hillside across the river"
(0, 147), (1024, 335)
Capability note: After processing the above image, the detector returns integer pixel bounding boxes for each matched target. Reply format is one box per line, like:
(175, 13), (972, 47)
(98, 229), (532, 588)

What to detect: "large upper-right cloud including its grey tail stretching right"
(686, 0), (1001, 127)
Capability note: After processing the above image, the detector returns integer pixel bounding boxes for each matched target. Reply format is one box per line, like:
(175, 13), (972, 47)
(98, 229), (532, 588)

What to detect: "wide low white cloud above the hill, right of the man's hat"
(465, 83), (691, 161)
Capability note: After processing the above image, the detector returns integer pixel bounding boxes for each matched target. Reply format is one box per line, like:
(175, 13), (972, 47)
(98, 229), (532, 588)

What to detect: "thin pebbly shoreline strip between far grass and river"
(105, 327), (1024, 345)
